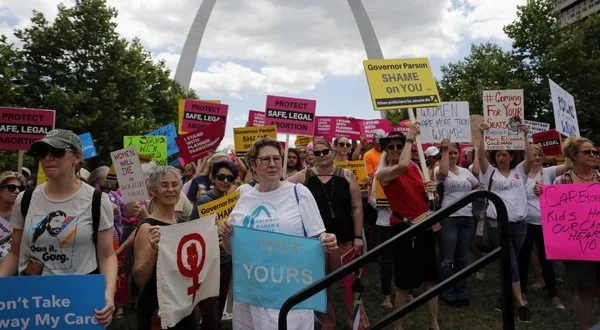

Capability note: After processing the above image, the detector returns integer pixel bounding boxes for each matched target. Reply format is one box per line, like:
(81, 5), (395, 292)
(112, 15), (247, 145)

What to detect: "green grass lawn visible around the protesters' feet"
(109, 263), (600, 330)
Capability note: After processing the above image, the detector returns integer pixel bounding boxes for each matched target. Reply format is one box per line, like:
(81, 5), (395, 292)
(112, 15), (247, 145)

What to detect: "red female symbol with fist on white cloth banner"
(177, 233), (206, 302)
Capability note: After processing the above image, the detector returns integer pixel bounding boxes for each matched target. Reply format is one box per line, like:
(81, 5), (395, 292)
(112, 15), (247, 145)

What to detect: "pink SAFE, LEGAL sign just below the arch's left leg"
(182, 100), (229, 132)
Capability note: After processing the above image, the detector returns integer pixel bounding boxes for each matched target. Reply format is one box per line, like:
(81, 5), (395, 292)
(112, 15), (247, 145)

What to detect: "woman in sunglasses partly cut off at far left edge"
(0, 171), (27, 263)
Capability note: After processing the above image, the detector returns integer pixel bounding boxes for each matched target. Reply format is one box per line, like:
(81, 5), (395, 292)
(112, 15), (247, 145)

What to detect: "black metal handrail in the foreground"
(278, 190), (515, 330)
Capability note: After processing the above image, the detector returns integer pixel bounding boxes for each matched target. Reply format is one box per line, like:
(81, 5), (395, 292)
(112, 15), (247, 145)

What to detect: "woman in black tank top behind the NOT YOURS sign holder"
(288, 140), (363, 330)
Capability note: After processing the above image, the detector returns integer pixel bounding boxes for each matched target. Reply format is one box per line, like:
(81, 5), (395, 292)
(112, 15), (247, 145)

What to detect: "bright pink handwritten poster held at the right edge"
(540, 183), (600, 261)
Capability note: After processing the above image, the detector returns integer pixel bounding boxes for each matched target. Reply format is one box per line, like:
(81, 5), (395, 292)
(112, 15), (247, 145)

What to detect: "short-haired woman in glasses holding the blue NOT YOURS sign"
(219, 139), (337, 330)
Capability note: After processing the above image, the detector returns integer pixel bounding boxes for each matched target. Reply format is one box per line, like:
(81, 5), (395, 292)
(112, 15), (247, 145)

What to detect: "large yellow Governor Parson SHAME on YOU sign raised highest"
(363, 58), (440, 110)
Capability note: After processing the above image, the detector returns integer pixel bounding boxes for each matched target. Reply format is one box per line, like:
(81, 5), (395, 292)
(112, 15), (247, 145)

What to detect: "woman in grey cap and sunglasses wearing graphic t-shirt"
(0, 129), (117, 325)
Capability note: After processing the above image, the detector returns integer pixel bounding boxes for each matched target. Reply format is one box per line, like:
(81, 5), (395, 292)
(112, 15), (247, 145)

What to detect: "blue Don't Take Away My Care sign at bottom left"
(0, 275), (104, 330)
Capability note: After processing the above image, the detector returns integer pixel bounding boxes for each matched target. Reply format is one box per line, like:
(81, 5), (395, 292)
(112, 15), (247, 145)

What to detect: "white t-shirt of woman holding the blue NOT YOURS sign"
(229, 181), (325, 330)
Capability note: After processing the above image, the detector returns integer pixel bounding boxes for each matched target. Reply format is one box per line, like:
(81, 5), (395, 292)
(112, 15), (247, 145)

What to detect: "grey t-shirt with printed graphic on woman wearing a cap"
(11, 183), (113, 275)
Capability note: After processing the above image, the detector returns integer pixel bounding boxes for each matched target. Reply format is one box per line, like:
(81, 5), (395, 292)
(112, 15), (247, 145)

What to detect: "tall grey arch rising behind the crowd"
(175, 0), (385, 118)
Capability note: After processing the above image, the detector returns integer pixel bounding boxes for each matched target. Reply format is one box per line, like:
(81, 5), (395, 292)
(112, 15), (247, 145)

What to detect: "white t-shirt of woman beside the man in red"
(433, 167), (479, 217)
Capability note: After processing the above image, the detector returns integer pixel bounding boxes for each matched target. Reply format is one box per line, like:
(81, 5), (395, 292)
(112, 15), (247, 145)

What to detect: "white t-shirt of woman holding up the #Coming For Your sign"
(479, 163), (527, 222)
